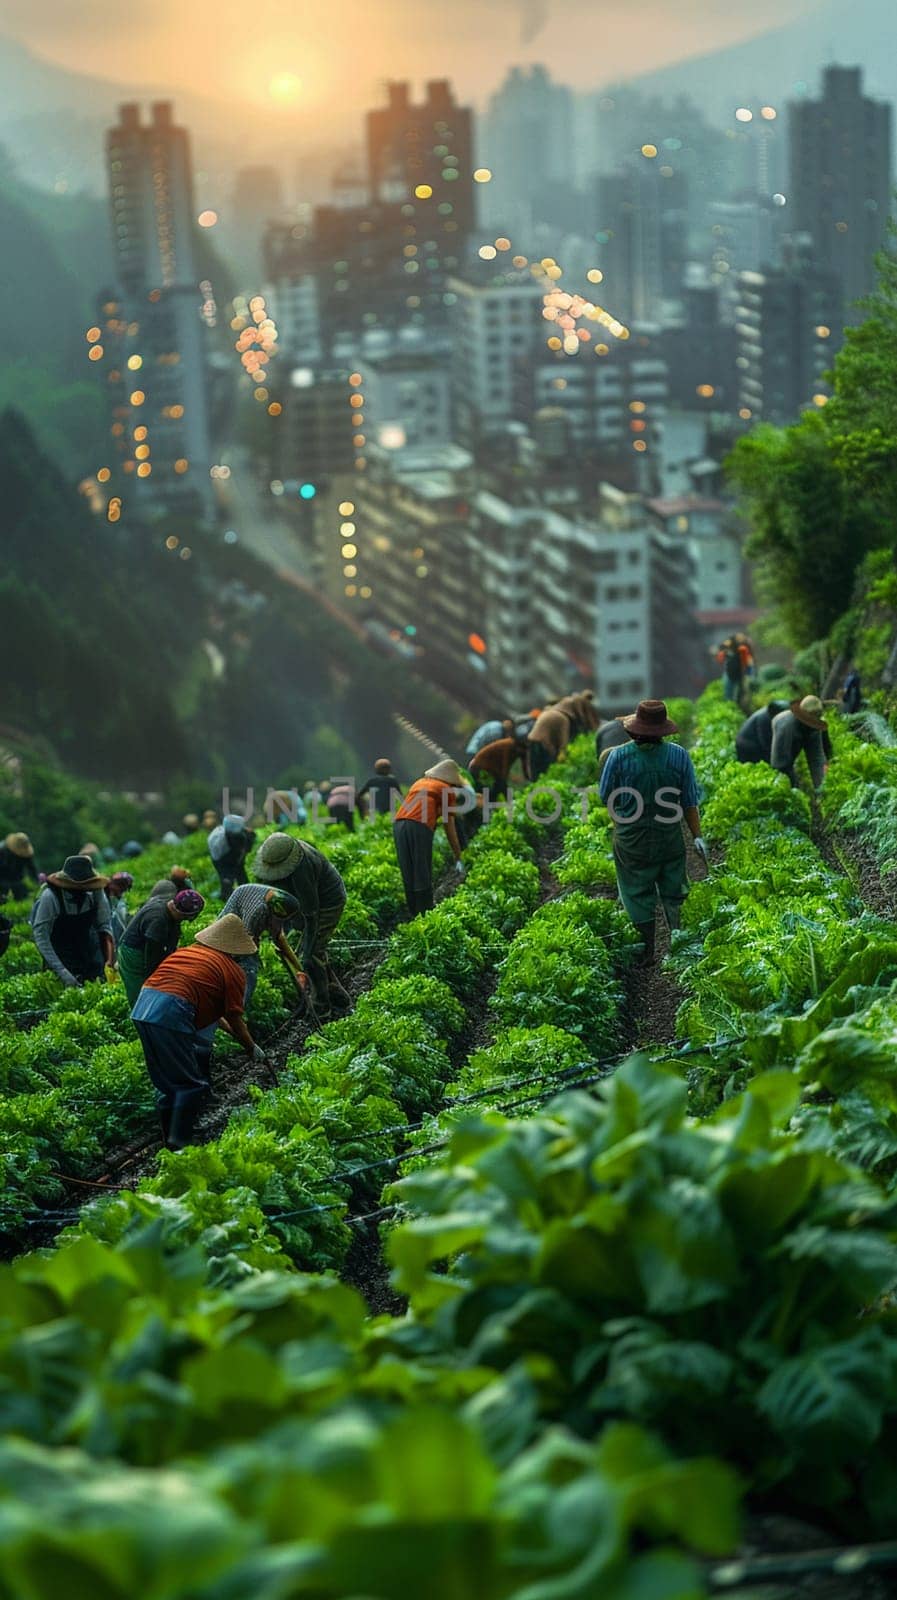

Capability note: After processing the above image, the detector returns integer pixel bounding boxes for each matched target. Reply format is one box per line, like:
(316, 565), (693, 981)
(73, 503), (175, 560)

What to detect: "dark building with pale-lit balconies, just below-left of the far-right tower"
(736, 250), (843, 422)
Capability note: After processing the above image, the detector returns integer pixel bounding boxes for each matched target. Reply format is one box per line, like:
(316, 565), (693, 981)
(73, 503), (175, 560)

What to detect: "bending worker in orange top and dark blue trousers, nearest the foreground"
(131, 917), (265, 1150)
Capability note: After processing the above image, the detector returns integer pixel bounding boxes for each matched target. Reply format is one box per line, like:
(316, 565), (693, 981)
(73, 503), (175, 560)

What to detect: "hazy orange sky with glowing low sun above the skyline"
(0, 0), (820, 104)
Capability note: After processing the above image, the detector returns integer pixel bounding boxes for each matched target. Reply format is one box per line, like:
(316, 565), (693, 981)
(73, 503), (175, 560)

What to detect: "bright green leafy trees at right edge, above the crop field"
(728, 230), (897, 710)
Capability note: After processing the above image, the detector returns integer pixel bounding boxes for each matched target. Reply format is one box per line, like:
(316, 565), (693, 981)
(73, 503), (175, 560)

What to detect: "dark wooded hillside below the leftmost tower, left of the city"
(0, 411), (451, 789)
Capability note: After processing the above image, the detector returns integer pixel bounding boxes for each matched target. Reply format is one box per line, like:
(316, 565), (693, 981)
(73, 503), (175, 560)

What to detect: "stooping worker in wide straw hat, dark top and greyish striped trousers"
(253, 834), (352, 1018)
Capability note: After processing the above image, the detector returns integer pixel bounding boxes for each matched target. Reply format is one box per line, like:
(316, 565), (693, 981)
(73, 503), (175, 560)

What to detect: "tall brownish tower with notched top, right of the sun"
(366, 78), (475, 236)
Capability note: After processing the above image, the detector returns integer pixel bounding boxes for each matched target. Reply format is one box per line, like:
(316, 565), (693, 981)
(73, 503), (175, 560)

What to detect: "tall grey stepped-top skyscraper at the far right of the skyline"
(787, 67), (892, 320)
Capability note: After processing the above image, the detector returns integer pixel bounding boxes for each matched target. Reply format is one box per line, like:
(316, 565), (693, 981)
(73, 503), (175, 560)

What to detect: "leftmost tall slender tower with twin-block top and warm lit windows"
(106, 101), (213, 514)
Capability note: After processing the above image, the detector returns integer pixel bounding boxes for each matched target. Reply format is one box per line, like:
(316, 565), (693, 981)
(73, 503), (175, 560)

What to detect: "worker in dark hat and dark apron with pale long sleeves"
(30, 856), (115, 989)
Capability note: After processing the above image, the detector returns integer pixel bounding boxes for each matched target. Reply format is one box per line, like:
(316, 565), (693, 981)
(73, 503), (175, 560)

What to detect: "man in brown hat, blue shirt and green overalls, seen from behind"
(600, 701), (707, 965)
